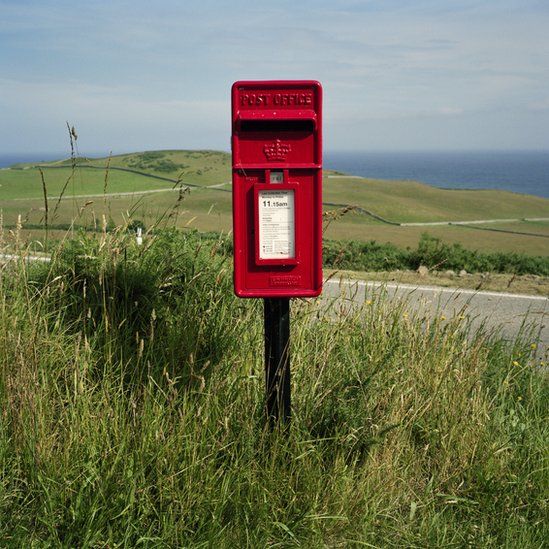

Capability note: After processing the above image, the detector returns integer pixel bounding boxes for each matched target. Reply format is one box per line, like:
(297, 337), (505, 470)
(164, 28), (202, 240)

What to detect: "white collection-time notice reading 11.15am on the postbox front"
(258, 190), (295, 259)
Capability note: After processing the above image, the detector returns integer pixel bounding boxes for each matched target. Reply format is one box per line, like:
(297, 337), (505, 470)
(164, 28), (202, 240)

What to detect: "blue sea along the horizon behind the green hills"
(0, 151), (549, 198)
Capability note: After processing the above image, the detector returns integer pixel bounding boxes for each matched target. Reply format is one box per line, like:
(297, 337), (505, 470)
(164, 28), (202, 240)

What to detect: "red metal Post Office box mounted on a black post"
(231, 80), (322, 298)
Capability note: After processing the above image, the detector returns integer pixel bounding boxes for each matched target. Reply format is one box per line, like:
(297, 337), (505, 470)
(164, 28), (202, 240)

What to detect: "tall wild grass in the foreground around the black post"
(0, 226), (549, 548)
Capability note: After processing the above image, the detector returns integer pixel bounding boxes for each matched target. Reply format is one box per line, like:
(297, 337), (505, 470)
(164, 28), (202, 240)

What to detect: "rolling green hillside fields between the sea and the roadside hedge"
(0, 151), (549, 255)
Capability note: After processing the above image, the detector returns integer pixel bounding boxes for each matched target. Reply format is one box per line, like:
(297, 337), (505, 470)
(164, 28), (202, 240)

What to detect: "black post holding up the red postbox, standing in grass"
(264, 298), (291, 427)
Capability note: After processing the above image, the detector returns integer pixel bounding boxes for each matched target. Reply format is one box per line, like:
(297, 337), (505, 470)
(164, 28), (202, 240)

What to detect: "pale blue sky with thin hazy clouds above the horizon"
(0, 0), (549, 154)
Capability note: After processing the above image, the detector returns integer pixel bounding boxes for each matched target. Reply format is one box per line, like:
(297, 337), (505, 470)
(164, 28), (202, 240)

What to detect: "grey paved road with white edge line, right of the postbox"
(323, 279), (549, 360)
